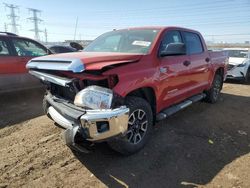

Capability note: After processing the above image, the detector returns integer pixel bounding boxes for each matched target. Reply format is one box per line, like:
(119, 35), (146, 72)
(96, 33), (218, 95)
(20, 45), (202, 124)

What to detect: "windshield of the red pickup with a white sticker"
(84, 29), (159, 54)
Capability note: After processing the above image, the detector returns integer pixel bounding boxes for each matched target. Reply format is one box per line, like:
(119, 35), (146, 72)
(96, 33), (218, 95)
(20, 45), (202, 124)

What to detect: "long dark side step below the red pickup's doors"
(156, 93), (206, 121)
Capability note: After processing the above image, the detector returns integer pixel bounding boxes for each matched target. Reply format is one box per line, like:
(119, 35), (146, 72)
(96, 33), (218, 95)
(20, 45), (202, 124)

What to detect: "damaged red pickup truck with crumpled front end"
(27, 27), (228, 155)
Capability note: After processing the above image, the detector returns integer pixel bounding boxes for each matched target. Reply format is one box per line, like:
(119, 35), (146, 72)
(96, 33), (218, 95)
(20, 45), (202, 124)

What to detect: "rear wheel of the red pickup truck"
(205, 74), (223, 103)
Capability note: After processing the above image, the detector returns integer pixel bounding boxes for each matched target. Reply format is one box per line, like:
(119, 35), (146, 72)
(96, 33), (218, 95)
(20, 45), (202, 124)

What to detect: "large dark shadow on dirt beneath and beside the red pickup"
(75, 94), (250, 188)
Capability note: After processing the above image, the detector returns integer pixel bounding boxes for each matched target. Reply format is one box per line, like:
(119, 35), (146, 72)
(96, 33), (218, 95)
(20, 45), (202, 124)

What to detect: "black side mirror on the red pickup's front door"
(160, 43), (186, 57)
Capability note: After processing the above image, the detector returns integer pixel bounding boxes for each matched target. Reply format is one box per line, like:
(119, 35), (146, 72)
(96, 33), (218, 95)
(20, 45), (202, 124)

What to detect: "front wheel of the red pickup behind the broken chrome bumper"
(108, 97), (153, 155)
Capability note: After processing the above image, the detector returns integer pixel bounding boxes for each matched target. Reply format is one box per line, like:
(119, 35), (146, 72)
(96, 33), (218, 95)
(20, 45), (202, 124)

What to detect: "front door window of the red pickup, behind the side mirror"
(160, 31), (182, 52)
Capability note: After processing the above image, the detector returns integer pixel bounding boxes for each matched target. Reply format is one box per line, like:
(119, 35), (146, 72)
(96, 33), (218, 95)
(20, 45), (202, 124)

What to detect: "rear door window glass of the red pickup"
(183, 32), (203, 55)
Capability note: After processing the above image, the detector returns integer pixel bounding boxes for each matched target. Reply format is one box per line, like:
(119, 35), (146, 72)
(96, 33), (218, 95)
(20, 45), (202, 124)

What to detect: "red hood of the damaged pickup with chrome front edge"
(26, 52), (143, 73)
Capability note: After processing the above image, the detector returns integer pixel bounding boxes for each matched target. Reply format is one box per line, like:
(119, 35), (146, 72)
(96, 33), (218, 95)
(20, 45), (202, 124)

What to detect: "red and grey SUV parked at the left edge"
(0, 32), (51, 93)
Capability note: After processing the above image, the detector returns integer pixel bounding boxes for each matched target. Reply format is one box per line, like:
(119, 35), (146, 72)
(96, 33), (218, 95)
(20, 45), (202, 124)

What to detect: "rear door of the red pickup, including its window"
(182, 31), (210, 96)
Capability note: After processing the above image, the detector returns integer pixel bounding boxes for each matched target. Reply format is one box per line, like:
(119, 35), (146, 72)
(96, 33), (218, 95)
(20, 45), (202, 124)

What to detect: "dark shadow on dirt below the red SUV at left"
(0, 88), (44, 129)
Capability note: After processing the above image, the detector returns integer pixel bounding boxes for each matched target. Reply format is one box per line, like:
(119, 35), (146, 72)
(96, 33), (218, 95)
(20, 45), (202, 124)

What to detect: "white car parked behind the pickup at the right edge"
(224, 48), (250, 82)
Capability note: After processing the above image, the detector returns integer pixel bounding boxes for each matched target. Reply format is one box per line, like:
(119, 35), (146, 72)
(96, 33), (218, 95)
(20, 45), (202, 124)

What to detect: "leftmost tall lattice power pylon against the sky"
(4, 3), (19, 34)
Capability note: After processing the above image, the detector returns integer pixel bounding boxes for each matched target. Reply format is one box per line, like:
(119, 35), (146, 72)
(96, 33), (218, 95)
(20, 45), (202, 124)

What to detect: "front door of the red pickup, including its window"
(159, 30), (190, 109)
